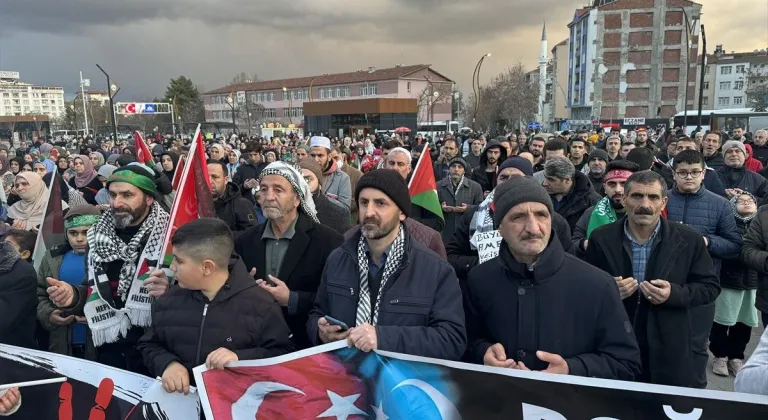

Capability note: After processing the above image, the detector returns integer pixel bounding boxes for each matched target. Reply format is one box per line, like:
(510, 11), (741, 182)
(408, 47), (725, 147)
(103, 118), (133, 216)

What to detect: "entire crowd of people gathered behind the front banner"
(0, 124), (768, 415)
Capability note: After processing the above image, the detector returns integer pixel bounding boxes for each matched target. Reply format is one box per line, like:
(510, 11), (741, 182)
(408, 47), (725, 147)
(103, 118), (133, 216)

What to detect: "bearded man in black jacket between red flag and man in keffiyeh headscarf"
(208, 159), (256, 233)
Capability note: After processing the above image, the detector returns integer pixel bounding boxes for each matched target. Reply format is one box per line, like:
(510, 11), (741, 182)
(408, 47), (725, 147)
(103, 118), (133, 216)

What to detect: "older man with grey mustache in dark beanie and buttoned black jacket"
(465, 177), (641, 381)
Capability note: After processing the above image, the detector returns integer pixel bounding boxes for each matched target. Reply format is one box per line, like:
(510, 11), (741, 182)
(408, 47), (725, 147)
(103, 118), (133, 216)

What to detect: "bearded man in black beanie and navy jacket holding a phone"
(307, 171), (467, 360)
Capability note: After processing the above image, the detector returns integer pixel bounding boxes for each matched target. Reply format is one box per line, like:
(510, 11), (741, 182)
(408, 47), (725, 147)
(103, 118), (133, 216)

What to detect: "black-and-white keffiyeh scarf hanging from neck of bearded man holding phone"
(355, 223), (405, 326)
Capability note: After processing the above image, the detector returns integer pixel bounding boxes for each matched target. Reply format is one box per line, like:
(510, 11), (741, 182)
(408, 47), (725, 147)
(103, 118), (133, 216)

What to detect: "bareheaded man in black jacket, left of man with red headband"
(542, 156), (600, 232)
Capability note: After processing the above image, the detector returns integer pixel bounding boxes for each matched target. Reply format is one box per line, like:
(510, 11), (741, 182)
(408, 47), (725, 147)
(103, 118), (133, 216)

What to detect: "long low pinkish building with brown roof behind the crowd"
(203, 64), (454, 130)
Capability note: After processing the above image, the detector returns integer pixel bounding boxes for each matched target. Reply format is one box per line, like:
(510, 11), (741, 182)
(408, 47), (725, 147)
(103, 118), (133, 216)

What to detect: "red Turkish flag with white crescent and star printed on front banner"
(198, 353), (370, 420)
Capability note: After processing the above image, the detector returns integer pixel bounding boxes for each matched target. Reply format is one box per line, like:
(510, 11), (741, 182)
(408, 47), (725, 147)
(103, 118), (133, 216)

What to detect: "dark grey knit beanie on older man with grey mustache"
(493, 176), (555, 229)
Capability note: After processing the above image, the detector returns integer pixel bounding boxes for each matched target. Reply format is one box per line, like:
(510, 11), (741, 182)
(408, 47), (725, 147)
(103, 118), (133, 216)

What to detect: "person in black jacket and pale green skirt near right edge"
(709, 192), (758, 376)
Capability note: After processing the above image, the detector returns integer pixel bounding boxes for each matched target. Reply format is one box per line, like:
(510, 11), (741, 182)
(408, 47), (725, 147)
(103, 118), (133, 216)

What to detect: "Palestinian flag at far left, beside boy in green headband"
(32, 171), (66, 271)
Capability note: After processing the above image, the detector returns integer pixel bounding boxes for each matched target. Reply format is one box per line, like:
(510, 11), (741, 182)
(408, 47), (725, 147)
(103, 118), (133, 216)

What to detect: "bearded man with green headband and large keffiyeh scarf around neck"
(47, 164), (169, 374)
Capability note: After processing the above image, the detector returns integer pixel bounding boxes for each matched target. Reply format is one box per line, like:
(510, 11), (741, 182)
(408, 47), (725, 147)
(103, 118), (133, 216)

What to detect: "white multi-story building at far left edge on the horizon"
(0, 71), (64, 118)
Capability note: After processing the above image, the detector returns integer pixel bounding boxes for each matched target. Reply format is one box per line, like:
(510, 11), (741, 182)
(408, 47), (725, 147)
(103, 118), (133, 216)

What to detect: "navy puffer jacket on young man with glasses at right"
(667, 186), (741, 274)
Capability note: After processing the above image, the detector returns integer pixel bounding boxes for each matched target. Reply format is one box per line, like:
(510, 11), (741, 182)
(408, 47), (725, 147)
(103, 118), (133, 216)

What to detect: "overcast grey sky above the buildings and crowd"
(0, 0), (768, 100)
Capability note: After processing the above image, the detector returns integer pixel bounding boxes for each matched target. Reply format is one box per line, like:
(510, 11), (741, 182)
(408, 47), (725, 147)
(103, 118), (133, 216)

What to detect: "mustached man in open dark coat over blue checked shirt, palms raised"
(586, 170), (720, 387)
